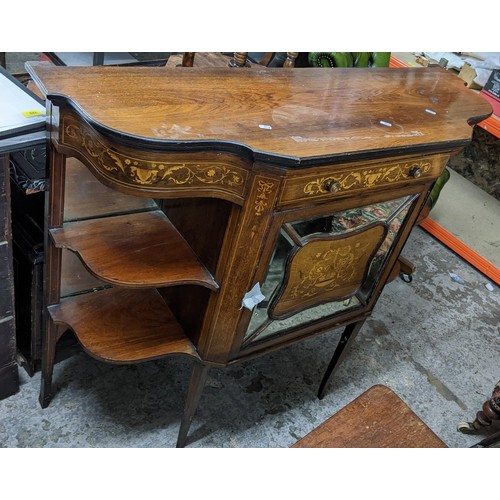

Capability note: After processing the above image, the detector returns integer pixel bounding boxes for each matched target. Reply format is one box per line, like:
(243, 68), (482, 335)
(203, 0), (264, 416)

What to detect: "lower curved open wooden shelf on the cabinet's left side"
(49, 288), (199, 363)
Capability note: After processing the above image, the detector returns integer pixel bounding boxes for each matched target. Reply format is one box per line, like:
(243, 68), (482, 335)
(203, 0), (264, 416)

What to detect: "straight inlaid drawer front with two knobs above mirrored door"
(280, 155), (448, 205)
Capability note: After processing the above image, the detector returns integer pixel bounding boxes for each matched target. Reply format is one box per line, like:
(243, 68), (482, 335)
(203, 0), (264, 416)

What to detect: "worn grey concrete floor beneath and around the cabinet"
(0, 228), (500, 448)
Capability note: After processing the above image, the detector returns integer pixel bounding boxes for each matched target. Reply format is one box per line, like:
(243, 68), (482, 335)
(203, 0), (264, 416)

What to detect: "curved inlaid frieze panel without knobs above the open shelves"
(59, 113), (249, 202)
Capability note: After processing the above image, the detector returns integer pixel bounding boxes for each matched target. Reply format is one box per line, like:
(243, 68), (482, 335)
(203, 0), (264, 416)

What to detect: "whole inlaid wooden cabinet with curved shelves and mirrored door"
(28, 63), (491, 446)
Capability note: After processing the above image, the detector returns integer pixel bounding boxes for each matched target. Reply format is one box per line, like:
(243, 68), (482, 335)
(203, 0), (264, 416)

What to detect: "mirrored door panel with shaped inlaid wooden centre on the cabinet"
(242, 195), (418, 349)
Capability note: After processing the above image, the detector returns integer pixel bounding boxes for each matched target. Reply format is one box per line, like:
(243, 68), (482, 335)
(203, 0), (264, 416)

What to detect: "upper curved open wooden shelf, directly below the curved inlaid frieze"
(50, 210), (218, 290)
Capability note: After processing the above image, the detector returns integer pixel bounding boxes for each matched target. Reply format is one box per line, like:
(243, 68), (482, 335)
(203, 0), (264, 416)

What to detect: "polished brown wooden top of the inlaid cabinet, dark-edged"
(27, 62), (491, 159)
